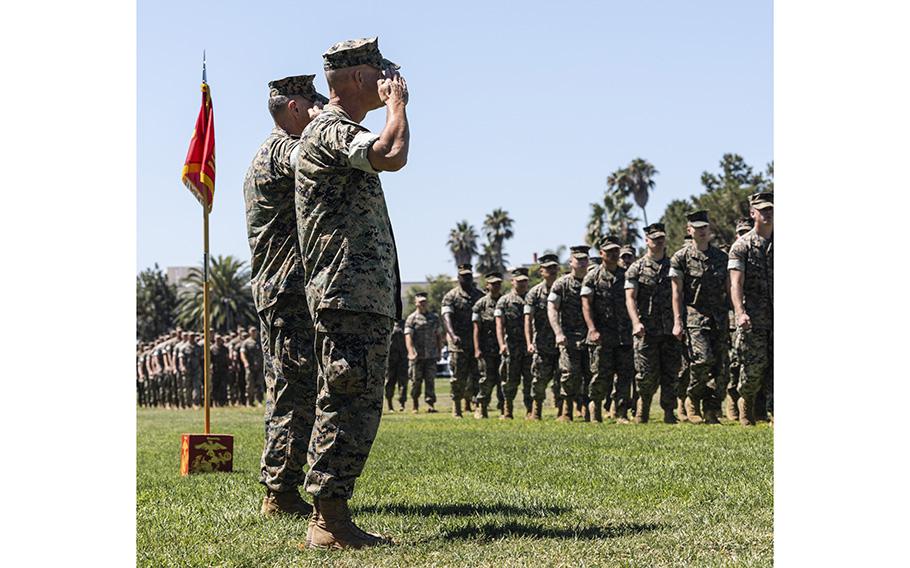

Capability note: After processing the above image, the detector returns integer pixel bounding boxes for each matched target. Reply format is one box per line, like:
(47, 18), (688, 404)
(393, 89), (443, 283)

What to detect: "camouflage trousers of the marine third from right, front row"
(634, 334), (682, 410)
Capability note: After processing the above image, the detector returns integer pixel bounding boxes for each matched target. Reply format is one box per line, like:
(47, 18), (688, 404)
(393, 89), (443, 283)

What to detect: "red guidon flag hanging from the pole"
(181, 79), (215, 212)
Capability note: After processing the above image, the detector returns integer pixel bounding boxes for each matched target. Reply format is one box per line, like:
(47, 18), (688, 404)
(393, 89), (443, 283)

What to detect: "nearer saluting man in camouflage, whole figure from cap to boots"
(295, 37), (410, 548)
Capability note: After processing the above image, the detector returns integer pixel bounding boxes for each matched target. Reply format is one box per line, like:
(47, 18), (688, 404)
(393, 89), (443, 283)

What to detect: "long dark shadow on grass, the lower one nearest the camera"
(441, 521), (660, 540)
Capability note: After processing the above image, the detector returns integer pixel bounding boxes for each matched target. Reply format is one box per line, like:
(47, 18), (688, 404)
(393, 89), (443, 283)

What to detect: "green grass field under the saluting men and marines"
(136, 380), (773, 567)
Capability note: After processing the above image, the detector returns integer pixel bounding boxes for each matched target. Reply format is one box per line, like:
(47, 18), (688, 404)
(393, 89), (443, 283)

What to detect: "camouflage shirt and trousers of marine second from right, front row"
(670, 245), (730, 411)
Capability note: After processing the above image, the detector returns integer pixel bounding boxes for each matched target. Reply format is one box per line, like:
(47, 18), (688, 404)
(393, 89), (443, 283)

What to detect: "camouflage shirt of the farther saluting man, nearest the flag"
(243, 126), (305, 311)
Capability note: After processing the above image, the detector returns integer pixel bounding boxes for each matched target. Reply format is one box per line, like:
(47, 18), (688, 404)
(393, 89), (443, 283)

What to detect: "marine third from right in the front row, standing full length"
(625, 223), (682, 424)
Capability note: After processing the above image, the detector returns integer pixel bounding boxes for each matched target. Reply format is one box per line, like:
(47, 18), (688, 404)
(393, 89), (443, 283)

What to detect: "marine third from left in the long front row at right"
(493, 267), (531, 419)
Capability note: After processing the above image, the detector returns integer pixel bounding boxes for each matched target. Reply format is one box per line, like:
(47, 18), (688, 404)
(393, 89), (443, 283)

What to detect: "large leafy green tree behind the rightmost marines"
(661, 154), (774, 254)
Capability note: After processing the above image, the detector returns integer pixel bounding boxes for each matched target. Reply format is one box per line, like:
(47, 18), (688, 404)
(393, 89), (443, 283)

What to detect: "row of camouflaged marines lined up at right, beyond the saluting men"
(414, 192), (774, 425)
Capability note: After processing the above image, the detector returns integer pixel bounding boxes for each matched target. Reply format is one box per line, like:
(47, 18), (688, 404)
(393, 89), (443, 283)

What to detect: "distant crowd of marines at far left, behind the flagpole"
(136, 327), (265, 408)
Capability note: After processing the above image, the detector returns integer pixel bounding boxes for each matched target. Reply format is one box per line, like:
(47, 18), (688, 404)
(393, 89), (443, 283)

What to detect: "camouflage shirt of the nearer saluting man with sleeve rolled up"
(295, 104), (401, 320)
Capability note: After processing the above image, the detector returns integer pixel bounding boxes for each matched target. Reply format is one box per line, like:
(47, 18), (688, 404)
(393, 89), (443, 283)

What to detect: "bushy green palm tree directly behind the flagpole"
(177, 255), (256, 331)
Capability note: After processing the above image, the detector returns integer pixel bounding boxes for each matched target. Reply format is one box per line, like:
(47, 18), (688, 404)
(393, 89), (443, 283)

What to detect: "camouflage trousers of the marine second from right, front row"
(684, 327), (730, 411)
